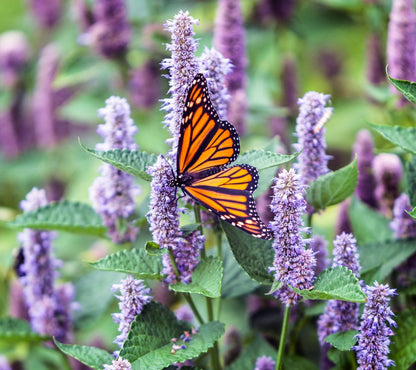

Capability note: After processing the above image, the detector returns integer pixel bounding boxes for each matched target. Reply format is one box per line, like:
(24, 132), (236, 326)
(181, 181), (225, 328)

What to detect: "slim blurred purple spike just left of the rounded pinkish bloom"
(353, 130), (377, 208)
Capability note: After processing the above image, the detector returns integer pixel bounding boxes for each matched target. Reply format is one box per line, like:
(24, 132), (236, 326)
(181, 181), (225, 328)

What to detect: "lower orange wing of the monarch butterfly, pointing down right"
(183, 164), (272, 239)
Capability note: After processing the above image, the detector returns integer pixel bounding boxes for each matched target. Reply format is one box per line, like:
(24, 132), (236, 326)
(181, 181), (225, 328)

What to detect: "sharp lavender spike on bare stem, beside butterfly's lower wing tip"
(270, 169), (316, 306)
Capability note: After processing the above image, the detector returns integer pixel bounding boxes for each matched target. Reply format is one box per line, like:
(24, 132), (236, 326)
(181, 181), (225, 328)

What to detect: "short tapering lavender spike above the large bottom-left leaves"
(112, 275), (152, 348)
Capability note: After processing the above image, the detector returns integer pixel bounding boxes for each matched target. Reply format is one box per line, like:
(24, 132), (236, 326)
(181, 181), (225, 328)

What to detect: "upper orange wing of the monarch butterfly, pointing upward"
(176, 73), (240, 175)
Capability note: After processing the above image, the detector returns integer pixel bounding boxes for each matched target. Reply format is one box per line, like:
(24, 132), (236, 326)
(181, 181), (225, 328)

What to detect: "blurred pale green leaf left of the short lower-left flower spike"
(74, 271), (124, 330)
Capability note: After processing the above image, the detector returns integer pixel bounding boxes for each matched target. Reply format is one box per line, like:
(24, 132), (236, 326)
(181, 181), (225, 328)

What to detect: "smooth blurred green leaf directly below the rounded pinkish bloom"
(349, 197), (393, 245)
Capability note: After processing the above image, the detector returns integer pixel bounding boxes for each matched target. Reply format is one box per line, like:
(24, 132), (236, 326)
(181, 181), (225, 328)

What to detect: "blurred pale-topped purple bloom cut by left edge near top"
(0, 31), (29, 88)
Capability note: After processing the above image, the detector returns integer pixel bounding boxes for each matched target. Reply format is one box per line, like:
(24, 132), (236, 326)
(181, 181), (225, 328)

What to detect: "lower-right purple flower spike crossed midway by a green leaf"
(318, 233), (361, 350)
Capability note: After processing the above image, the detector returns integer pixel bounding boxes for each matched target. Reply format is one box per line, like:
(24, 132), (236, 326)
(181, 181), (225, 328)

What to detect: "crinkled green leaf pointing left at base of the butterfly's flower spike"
(91, 248), (163, 280)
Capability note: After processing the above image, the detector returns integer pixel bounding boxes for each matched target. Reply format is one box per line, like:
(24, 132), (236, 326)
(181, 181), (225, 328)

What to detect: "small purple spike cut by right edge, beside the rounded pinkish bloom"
(390, 193), (416, 239)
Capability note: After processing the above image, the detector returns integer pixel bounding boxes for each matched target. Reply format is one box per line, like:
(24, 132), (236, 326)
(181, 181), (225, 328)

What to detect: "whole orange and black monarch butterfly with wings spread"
(172, 73), (272, 239)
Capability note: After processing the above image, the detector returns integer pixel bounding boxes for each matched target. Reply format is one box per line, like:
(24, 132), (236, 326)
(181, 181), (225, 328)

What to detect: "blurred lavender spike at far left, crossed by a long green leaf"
(18, 188), (74, 342)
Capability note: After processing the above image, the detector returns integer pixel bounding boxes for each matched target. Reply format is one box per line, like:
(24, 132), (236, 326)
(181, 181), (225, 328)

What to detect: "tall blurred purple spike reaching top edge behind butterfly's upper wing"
(213, 0), (247, 135)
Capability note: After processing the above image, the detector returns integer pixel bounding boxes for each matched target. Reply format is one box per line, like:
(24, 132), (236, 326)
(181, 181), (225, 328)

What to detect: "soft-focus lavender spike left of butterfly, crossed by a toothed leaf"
(89, 96), (140, 243)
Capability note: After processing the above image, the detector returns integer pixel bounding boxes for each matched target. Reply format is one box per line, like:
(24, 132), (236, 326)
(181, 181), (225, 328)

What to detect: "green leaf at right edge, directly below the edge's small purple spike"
(358, 239), (416, 285)
